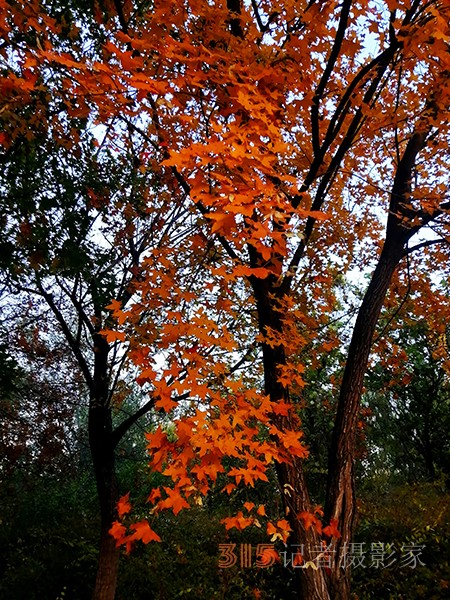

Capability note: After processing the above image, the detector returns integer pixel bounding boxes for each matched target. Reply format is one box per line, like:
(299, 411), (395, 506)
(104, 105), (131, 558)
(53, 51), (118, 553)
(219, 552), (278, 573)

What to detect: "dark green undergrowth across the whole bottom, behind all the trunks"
(0, 448), (450, 600)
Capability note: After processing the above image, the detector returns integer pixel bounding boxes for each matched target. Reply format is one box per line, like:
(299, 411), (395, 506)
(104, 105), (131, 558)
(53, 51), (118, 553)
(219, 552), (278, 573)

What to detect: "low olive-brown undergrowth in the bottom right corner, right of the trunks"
(353, 483), (450, 600)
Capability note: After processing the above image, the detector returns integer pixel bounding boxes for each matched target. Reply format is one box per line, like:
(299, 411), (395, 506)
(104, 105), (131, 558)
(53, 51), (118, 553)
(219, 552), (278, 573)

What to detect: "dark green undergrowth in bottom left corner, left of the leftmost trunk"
(0, 474), (97, 600)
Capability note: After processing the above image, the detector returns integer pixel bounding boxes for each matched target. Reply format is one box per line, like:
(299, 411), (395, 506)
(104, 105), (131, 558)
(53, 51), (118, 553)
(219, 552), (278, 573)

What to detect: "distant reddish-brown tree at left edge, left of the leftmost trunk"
(0, 331), (84, 476)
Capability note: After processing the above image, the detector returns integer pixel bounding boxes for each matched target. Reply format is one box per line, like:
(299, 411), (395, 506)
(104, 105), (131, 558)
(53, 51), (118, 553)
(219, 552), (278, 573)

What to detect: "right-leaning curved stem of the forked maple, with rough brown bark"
(325, 131), (427, 600)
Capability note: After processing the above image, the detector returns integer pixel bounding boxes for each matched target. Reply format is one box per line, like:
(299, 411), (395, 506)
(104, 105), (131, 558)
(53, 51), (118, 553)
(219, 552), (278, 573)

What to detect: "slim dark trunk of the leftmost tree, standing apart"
(89, 334), (119, 600)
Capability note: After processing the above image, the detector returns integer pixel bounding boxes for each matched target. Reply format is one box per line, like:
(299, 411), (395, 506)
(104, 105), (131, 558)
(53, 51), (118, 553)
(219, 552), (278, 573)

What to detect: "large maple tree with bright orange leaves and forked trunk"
(0, 0), (450, 600)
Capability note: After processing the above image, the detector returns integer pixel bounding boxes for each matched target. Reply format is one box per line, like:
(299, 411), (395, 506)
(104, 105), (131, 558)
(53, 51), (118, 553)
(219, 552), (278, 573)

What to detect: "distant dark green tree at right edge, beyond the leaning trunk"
(364, 320), (450, 482)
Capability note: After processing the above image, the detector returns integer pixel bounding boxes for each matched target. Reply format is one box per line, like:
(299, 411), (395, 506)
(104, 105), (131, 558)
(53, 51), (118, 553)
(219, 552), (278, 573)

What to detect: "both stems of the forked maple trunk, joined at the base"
(250, 125), (433, 600)
